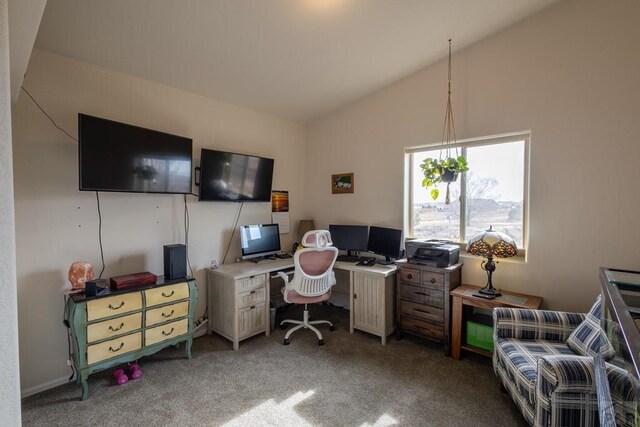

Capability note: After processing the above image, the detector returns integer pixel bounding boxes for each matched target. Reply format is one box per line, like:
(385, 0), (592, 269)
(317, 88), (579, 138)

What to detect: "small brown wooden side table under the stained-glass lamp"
(451, 285), (542, 360)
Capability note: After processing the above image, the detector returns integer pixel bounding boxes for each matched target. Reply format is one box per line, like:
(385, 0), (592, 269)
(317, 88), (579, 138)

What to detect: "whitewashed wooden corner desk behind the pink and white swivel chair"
(206, 258), (397, 350)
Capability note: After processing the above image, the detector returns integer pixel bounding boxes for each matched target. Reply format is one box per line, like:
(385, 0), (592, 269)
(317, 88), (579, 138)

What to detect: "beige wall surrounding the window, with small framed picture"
(307, 0), (640, 310)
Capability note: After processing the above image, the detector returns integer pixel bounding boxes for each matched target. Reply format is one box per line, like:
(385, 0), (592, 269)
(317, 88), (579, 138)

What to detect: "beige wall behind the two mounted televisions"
(13, 50), (305, 393)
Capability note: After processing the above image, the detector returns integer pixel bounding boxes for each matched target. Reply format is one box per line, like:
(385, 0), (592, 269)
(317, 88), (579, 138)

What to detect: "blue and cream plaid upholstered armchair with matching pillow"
(493, 297), (635, 426)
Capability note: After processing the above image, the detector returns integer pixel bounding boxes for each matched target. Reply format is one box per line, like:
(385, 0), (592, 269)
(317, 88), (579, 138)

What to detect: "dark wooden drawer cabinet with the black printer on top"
(397, 264), (462, 355)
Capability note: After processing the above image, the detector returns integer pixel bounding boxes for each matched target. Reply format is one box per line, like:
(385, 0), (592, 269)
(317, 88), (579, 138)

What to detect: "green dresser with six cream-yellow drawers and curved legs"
(68, 278), (198, 400)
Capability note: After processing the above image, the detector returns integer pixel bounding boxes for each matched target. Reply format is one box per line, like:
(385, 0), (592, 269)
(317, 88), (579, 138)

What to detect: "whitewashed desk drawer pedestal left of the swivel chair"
(207, 269), (270, 350)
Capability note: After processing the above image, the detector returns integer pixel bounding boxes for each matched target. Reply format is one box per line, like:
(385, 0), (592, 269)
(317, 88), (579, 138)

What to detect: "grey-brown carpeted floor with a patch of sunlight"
(22, 306), (526, 427)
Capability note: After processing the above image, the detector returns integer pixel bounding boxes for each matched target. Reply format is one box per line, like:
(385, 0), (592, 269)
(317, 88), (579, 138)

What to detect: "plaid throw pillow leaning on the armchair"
(567, 296), (615, 360)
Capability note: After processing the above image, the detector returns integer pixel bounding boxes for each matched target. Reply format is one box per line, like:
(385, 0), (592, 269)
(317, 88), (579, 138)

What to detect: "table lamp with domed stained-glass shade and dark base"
(467, 226), (518, 298)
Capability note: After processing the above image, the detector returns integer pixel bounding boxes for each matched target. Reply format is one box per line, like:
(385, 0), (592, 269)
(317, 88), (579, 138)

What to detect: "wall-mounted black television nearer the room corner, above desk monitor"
(200, 148), (273, 202)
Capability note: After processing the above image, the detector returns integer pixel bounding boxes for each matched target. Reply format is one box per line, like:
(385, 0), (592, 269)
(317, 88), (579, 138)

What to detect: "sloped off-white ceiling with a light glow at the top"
(35, 0), (557, 122)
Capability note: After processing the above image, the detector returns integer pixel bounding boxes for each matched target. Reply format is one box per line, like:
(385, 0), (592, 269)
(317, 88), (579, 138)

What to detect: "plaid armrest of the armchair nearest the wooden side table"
(493, 307), (585, 342)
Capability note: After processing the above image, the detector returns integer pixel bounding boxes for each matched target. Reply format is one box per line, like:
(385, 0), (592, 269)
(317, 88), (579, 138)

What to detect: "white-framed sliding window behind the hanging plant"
(405, 133), (529, 254)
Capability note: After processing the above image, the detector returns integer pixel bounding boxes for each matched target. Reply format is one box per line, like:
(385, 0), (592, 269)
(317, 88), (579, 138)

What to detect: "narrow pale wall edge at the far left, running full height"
(0, 0), (20, 426)
